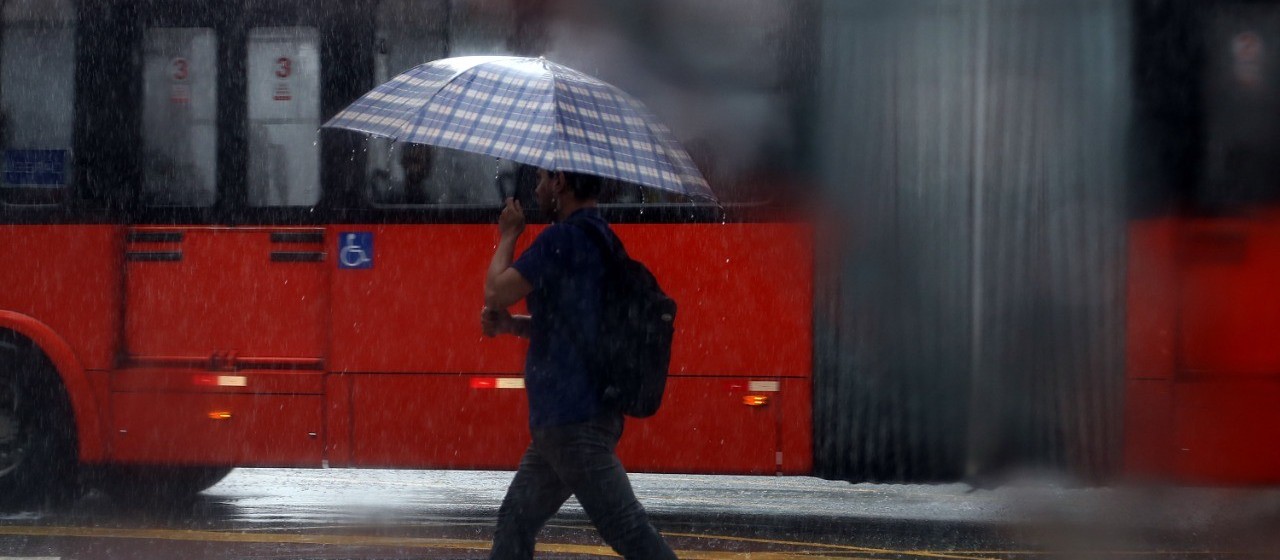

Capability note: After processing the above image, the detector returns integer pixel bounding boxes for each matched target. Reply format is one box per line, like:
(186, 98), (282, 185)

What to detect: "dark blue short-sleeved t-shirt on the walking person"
(512, 208), (609, 427)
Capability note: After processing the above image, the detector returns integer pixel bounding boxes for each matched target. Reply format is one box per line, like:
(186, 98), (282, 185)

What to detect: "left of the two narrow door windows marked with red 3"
(142, 28), (218, 206)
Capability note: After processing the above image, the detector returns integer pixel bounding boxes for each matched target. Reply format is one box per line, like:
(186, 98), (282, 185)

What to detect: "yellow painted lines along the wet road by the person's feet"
(0, 525), (998, 560)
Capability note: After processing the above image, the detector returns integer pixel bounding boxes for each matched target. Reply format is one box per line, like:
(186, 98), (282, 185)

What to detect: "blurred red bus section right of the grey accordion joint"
(1124, 1), (1280, 485)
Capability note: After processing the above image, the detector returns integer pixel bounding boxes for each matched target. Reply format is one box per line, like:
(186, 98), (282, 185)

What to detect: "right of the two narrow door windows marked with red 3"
(248, 27), (320, 206)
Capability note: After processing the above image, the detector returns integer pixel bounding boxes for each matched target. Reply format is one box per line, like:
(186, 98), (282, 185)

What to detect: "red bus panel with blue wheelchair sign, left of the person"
(328, 225), (527, 468)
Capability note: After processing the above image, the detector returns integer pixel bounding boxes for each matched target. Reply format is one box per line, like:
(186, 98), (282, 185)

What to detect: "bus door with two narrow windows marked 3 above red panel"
(113, 27), (329, 465)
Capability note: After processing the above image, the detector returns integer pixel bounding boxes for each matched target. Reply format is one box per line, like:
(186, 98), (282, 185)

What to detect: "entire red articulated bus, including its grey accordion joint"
(0, 0), (1280, 505)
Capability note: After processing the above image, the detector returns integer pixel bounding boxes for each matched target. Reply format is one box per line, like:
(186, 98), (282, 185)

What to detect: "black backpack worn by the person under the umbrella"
(568, 220), (676, 418)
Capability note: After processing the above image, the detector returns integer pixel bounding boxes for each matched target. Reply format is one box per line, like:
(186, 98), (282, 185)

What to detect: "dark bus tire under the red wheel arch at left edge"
(0, 331), (81, 510)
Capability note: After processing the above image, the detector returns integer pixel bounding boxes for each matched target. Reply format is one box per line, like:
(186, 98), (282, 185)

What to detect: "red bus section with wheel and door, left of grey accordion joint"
(0, 1), (813, 501)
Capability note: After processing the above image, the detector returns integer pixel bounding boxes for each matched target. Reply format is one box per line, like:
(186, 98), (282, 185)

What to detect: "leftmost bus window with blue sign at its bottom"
(0, 0), (76, 205)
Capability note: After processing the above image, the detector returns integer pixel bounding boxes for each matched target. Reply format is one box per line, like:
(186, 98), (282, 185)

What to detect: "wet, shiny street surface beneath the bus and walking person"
(0, 469), (1280, 560)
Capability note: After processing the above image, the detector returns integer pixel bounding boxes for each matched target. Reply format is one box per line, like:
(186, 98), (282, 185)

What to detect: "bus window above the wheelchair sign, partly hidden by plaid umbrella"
(367, 0), (506, 207)
